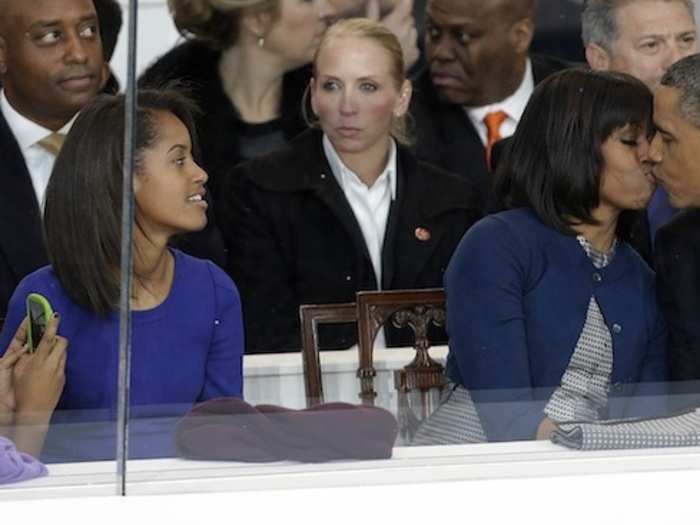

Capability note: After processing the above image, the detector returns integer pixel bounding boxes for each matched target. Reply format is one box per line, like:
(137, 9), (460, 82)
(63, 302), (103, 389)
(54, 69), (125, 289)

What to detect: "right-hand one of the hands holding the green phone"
(13, 314), (68, 422)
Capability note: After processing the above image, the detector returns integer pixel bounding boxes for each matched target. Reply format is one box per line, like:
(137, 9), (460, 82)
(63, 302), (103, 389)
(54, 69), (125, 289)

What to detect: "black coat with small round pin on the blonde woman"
(219, 130), (480, 352)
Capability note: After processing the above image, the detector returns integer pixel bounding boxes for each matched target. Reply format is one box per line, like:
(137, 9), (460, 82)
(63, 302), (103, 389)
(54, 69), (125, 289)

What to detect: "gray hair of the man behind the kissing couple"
(581, 0), (695, 52)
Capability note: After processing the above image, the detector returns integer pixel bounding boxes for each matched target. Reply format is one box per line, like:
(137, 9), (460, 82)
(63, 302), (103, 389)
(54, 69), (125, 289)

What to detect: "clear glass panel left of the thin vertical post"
(0, 0), (124, 499)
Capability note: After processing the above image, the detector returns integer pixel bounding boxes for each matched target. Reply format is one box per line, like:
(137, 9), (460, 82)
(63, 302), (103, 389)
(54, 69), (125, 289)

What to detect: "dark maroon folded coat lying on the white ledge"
(175, 398), (398, 462)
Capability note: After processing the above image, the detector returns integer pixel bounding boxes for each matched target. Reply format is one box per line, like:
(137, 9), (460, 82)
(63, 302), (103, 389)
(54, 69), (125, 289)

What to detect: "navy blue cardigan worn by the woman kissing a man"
(445, 208), (667, 441)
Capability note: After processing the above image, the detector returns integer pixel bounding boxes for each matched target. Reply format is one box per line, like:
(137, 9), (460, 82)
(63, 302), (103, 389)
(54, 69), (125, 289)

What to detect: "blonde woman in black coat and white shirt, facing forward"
(221, 19), (479, 352)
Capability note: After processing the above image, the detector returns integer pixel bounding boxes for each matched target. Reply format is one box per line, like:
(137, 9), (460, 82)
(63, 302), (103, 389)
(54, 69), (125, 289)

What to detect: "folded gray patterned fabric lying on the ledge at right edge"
(552, 409), (700, 450)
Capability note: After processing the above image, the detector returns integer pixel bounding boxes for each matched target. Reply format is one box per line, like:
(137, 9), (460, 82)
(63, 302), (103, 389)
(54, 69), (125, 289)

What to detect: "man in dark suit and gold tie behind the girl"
(0, 0), (104, 317)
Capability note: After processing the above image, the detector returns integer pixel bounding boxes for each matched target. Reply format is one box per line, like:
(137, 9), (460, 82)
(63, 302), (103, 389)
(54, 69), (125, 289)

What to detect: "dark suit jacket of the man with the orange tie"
(411, 55), (572, 208)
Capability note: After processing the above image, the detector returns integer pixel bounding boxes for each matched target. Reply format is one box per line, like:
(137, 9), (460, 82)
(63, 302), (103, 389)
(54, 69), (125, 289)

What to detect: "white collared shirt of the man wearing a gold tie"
(0, 90), (75, 213)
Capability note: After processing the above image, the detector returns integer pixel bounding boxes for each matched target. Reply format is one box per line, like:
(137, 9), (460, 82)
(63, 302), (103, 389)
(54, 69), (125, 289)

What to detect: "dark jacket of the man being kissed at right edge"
(654, 210), (700, 381)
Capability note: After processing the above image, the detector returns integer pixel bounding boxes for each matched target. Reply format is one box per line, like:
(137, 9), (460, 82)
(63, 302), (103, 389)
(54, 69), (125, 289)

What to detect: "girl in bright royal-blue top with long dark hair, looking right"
(0, 90), (243, 461)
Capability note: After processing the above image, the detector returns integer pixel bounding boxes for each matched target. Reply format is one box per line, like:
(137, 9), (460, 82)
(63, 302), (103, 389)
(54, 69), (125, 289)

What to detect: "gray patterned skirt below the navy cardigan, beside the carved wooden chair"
(411, 383), (486, 445)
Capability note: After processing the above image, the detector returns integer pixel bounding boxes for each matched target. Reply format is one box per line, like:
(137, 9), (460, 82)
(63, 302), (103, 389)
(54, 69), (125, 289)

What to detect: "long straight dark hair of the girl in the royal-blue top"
(44, 88), (196, 316)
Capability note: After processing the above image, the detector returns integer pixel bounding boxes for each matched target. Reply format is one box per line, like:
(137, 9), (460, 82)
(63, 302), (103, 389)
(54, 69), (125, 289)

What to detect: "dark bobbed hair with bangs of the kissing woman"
(495, 69), (654, 235)
